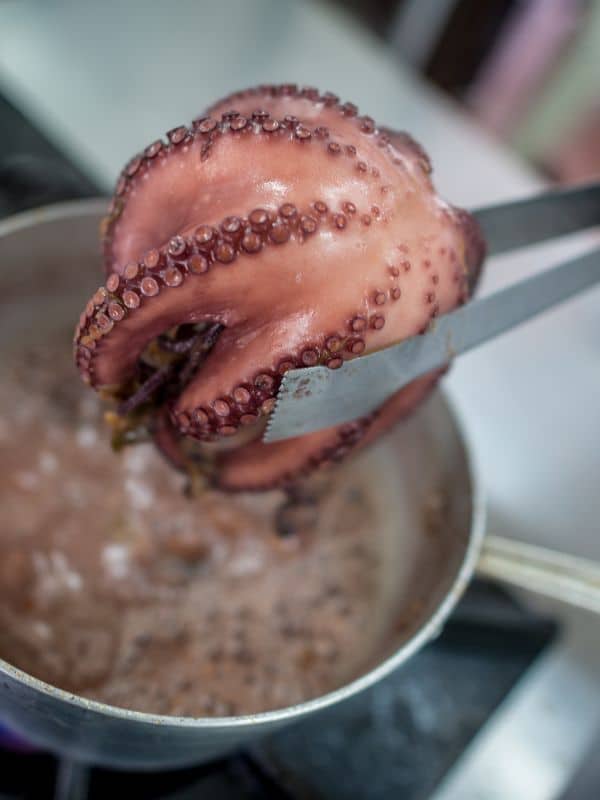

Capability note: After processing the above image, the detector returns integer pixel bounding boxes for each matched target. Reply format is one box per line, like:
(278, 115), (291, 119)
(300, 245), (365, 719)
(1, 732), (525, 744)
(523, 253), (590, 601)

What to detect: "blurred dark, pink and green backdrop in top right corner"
(339, 0), (600, 182)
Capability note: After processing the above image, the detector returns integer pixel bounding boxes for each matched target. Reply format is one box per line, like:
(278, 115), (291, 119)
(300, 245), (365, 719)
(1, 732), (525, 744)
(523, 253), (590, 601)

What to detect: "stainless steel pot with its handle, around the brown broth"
(0, 200), (600, 769)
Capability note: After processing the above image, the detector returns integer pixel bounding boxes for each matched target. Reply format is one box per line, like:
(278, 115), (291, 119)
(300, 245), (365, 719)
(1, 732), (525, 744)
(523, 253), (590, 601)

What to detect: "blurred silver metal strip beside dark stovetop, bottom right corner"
(431, 603), (600, 800)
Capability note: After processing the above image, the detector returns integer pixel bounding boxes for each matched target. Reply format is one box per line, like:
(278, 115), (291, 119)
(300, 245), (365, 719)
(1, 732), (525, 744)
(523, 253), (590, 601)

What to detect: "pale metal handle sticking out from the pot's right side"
(475, 535), (600, 614)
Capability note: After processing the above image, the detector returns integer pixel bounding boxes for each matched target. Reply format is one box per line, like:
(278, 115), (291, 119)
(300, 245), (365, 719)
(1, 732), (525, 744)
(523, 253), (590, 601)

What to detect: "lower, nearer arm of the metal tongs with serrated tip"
(264, 242), (600, 442)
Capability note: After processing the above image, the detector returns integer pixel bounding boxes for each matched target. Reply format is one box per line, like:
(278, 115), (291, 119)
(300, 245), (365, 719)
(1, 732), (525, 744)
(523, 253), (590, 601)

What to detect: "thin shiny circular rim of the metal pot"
(0, 197), (486, 730)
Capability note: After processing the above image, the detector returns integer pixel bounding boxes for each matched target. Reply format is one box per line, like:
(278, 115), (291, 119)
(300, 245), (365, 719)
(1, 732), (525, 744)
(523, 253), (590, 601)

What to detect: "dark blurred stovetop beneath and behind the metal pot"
(0, 89), (556, 800)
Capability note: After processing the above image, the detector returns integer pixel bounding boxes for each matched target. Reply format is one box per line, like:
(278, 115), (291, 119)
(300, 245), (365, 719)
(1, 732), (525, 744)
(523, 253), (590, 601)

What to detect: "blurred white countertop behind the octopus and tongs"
(0, 0), (600, 800)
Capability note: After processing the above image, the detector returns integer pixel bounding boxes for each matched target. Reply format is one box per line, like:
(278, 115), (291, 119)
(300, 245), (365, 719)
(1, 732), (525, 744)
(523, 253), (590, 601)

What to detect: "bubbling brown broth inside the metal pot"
(0, 336), (404, 716)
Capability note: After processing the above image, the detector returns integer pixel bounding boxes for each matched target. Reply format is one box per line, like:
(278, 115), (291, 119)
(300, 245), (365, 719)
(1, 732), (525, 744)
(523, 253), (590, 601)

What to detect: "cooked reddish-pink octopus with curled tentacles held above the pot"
(74, 84), (485, 491)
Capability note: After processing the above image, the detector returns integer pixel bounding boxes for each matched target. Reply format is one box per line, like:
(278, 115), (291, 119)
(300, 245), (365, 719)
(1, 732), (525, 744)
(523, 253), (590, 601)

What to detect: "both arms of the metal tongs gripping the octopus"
(264, 183), (600, 442)
